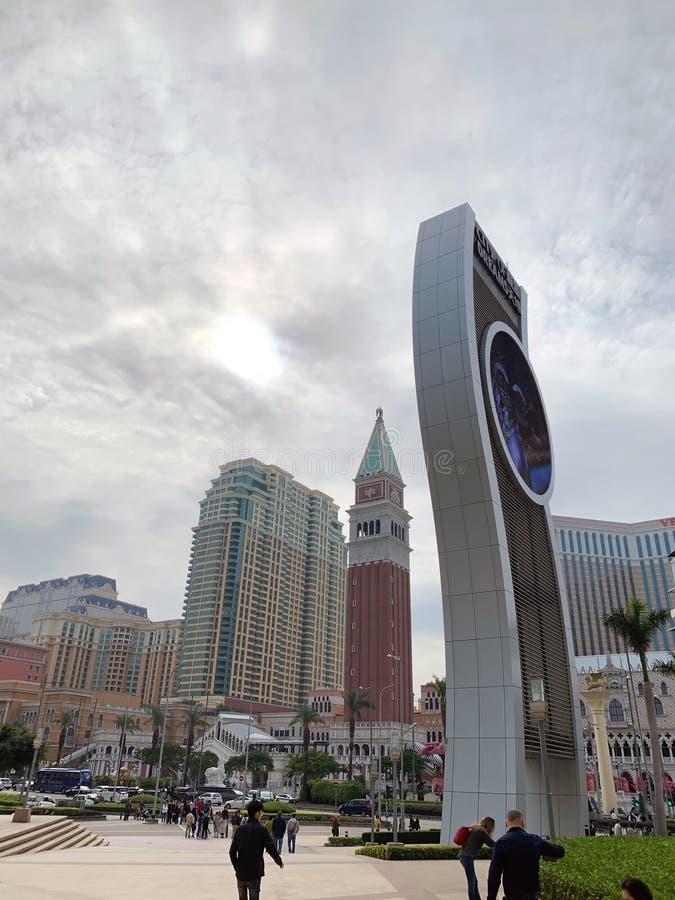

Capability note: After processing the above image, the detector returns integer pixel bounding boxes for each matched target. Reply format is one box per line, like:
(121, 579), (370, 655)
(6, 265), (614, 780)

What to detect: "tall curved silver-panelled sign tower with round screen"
(413, 204), (588, 842)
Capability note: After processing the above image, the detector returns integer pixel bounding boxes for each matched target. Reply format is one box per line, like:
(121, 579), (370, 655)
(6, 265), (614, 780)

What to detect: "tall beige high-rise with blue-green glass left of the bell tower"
(178, 459), (346, 706)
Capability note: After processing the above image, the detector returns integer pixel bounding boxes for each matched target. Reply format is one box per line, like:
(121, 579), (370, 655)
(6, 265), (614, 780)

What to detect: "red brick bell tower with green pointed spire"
(344, 409), (413, 723)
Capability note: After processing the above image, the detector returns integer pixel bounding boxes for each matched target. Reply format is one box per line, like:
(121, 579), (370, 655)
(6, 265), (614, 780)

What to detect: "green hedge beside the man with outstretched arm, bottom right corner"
(541, 835), (675, 900)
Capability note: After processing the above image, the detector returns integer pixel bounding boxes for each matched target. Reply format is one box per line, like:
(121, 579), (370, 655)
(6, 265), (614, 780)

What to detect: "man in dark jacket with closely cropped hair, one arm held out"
(487, 809), (565, 900)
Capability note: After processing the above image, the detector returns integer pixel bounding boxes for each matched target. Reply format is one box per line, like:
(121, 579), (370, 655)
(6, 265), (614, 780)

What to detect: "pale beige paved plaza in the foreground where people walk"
(0, 817), (488, 900)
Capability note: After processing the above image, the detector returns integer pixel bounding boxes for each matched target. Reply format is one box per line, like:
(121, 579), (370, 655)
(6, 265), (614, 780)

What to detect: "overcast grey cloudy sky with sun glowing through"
(0, 0), (675, 683)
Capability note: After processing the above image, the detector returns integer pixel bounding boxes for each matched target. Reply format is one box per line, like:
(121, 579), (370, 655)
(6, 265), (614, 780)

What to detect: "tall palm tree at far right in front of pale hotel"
(603, 597), (670, 837)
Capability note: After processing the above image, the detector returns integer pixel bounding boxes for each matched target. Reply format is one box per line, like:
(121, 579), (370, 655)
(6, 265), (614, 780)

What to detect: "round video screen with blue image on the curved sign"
(486, 329), (553, 500)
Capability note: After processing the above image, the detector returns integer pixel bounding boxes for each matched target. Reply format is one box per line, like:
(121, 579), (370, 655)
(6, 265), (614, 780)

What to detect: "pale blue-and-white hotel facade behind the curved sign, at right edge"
(553, 516), (675, 656)
